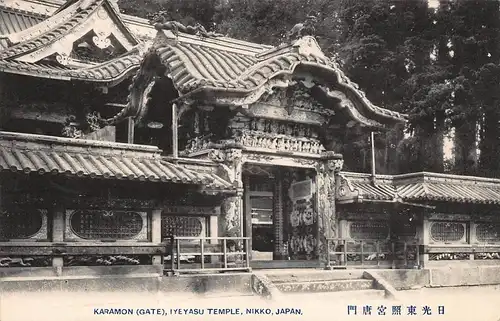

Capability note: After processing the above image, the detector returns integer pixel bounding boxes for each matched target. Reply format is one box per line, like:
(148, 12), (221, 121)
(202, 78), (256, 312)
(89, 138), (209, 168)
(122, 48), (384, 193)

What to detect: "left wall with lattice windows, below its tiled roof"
(0, 176), (221, 275)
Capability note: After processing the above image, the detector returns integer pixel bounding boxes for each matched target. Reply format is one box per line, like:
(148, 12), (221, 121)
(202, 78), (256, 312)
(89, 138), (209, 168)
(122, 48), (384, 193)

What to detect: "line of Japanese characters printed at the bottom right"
(347, 305), (445, 316)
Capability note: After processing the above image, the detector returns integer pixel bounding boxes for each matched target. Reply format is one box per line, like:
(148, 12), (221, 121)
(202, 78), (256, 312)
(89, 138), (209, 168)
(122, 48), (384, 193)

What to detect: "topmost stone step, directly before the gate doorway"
(266, 270), (363, 283)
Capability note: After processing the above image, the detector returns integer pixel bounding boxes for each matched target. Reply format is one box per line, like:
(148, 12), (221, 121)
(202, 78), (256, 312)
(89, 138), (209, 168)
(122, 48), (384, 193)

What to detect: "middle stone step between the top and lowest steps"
(275, 279), (373, 292)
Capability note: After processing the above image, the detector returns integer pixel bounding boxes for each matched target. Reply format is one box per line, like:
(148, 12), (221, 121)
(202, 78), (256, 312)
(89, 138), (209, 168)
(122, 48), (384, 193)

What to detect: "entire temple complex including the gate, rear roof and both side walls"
(0, 0), (500, 273)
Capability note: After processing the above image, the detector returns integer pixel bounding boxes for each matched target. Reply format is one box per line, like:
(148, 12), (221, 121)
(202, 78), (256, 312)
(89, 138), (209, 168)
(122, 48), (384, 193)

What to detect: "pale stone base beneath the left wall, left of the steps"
(0, 266), (252, 294)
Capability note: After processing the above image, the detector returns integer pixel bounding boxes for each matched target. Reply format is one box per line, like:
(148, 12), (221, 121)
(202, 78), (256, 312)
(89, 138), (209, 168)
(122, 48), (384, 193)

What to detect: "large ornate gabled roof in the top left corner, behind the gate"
(0, 0), (270, 84)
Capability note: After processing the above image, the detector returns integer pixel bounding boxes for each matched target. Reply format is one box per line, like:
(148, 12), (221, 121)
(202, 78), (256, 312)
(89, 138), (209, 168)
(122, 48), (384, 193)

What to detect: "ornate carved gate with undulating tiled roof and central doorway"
(121, 25), (404, 266)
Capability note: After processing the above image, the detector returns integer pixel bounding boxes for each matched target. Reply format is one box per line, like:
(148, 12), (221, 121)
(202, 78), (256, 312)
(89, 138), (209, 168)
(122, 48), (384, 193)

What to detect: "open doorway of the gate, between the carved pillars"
(243, 164), (319, 268)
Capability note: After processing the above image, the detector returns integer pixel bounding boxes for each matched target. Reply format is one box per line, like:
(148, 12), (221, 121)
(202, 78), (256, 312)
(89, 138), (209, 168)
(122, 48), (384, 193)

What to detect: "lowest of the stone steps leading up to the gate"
(283, 289), (386, 304)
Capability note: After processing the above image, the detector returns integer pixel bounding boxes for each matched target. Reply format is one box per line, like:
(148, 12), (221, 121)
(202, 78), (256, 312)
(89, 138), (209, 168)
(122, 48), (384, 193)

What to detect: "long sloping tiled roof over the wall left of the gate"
(0, 134), (232, 189)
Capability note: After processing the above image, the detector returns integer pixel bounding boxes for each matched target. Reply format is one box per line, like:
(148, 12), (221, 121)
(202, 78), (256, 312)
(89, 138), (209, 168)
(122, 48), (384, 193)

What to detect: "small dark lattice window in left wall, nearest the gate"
(161, 215), (203, 238)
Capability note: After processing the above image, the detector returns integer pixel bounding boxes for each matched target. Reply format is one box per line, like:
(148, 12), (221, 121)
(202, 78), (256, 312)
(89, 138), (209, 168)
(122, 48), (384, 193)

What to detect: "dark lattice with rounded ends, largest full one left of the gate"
(70, 210), (144, 240)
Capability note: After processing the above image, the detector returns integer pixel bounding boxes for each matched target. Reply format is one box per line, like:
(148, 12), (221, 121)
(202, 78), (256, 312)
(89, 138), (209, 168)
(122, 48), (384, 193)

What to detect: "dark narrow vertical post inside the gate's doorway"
(273, 169), (284, 260)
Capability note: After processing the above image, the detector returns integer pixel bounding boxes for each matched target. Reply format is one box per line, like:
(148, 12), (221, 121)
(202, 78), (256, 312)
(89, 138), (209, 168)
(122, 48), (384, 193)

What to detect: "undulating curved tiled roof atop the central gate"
(133, 30), (407, 128)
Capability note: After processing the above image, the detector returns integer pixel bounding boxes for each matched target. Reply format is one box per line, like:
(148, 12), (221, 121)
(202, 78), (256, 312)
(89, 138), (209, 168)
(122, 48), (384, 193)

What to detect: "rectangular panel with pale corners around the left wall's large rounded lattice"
(65, 209), (148, 241)
